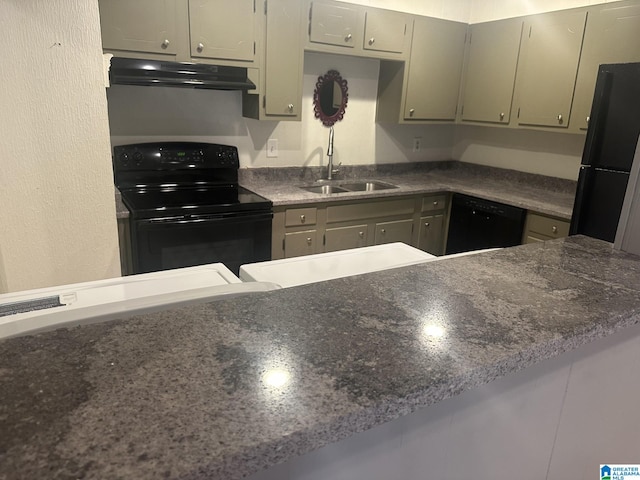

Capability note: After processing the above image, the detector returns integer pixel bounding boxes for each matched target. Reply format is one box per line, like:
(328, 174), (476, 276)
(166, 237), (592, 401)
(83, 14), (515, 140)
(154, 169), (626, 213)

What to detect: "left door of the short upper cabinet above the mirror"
(309, 2), (362, 48)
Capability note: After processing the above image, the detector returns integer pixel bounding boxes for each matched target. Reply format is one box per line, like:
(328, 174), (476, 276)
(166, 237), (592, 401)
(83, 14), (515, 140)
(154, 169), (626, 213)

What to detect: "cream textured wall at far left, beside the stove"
(0, 0), (120, 291)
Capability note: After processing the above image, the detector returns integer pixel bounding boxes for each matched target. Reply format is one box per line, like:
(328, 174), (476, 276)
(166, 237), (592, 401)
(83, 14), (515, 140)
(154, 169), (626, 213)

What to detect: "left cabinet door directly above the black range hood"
(98, 0), (177, 55)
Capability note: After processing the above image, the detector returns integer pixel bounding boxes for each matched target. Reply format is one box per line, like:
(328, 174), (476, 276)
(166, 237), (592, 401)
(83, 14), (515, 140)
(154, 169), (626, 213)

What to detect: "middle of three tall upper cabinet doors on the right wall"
(517, 11), (587, 128)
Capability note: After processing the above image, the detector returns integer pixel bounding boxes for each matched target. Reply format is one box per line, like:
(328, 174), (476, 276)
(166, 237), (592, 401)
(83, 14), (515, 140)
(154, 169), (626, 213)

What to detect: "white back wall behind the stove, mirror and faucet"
(107, 53), (454, 167)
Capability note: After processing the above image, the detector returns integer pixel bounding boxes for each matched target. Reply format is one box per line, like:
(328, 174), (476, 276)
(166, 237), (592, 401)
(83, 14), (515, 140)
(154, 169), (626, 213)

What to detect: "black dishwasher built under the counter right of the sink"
(446, 193), (527, 254)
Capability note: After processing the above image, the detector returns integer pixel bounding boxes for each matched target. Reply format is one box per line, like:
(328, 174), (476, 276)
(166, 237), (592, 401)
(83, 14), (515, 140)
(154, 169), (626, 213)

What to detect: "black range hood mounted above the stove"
(109, 57), (256, 90)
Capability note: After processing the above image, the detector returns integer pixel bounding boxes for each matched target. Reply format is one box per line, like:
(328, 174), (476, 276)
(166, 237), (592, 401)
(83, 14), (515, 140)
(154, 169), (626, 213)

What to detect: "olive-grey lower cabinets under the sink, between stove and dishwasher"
(272, 194), (448, 260)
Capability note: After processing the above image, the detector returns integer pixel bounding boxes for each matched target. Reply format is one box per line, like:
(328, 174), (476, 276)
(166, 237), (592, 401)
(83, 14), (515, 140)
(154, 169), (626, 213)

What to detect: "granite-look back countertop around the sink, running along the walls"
(116, 161), (576, 220)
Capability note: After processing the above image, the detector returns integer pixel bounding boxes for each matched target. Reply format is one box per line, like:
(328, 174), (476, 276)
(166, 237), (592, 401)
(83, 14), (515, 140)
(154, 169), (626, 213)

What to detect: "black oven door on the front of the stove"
(131, 212), (273, 275)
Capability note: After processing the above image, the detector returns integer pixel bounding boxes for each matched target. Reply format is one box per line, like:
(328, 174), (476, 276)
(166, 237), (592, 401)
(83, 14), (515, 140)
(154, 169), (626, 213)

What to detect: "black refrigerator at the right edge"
(569, 63), (640, 242)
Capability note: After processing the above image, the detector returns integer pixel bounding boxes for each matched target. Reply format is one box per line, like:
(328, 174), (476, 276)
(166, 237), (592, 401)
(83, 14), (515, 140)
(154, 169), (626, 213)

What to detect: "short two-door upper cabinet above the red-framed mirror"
(305, 0), (413, 59)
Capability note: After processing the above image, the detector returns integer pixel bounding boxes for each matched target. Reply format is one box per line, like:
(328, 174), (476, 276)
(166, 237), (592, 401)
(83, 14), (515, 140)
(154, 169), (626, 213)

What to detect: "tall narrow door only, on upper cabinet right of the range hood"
(264, 0), (303, 117)
